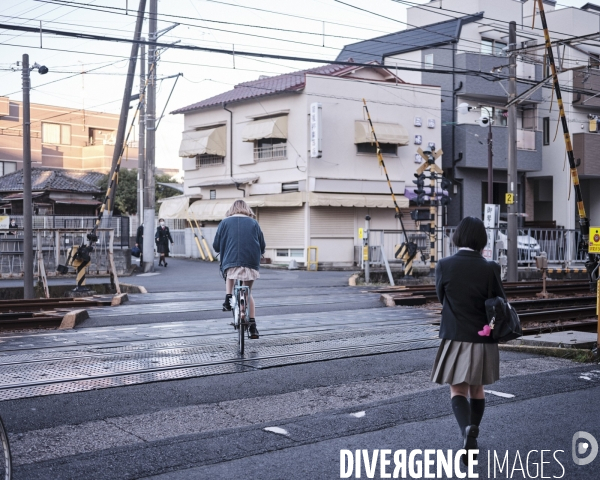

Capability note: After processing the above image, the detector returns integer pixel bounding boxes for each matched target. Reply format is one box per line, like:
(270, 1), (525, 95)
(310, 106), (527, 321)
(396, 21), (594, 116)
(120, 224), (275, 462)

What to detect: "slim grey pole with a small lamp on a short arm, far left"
(22, 53), (48, 299)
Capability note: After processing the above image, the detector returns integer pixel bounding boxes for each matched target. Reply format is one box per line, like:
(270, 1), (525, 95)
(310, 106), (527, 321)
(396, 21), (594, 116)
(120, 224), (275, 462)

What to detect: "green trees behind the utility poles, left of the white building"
(98, 168), (179, 215)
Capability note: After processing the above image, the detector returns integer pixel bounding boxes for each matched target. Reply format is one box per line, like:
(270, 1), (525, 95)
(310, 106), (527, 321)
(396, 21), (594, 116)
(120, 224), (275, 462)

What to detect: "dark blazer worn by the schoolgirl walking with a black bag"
(435, 250), (506, 343)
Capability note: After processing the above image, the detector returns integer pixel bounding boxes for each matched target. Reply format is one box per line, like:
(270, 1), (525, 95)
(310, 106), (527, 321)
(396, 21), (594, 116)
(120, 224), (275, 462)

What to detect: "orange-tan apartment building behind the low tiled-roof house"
(0, 97), (138, 176)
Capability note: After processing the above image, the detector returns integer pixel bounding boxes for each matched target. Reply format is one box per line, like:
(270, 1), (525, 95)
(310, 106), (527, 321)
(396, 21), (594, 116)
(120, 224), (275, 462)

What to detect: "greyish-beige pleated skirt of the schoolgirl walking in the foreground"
(431, 339), (500, 385)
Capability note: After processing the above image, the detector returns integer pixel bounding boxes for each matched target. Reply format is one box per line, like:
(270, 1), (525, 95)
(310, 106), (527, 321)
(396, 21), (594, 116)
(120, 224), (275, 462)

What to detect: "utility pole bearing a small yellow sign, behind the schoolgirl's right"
(506, 21), (519, 282)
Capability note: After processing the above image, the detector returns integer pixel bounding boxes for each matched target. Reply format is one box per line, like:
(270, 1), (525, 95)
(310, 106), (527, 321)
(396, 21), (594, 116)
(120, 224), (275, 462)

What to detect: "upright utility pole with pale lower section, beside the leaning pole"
(142, 0), (158, 272)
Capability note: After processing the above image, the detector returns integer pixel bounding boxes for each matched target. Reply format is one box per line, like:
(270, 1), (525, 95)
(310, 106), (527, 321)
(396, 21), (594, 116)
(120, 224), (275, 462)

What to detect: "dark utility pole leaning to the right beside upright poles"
(105, 0), (146, 221)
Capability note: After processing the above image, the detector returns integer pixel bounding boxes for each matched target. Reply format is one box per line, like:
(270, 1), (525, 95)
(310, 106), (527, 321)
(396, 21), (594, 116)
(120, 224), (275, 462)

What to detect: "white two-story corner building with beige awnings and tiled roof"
(166, 64), (443, 264)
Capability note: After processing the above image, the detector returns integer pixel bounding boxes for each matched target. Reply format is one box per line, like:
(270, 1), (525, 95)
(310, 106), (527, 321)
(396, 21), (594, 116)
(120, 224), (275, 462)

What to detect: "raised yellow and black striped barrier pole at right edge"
(534, 0), (597, 280)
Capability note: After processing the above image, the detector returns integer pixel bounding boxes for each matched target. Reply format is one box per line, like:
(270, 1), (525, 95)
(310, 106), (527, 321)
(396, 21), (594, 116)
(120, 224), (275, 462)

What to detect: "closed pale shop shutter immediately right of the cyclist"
(257, 207), (304, 248)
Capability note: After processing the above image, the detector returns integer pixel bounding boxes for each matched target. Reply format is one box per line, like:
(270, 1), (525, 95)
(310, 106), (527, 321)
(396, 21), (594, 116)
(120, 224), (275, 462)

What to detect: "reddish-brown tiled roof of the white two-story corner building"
(171, 65), (349, 114)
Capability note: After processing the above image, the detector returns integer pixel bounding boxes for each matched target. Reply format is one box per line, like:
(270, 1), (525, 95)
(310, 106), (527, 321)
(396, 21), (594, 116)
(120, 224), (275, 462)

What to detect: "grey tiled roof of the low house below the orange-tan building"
(0, 168), (103, 193)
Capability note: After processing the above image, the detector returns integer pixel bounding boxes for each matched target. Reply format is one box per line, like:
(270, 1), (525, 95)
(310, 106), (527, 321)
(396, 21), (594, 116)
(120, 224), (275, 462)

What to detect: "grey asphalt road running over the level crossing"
(0, 259), (600, 480)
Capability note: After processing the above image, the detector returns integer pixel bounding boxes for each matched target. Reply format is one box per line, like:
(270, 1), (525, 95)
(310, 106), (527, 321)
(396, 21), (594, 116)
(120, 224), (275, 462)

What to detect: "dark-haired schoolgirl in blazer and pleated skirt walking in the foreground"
(431, 217), (506, 465)
